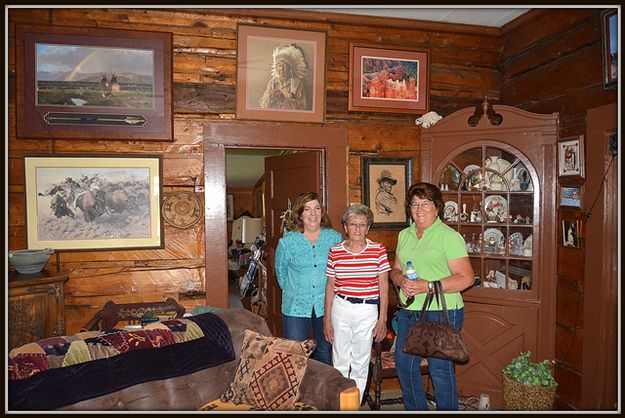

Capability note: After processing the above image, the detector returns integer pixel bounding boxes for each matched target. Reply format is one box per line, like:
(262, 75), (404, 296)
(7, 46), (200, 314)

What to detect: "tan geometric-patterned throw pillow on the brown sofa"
(220, 329), (316, 410)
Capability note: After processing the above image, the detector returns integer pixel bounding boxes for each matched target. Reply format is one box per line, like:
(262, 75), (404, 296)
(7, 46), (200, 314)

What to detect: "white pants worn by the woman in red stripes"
(332, 295), (378, 400)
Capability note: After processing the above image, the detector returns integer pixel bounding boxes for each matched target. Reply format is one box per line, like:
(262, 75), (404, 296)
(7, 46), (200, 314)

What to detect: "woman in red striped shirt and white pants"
(323, 203), (391, 400)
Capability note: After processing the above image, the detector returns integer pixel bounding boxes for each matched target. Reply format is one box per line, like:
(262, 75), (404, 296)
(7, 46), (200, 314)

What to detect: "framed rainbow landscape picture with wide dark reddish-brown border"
(15, 25), (173, 141)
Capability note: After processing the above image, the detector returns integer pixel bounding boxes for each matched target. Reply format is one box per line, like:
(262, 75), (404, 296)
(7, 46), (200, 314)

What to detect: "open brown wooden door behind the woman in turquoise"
(265, 151), (323, 337)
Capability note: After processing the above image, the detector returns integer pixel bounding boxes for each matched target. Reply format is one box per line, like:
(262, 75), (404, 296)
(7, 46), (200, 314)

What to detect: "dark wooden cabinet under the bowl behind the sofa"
(8, 270), (68, 350)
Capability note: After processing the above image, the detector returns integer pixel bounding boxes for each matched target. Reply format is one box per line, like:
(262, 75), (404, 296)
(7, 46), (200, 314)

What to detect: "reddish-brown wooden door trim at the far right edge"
(580, 103), (618, 410)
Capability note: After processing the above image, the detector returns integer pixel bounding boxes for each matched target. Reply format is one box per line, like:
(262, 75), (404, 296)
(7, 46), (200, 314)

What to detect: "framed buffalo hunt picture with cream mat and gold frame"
(24, 154), (164, 250)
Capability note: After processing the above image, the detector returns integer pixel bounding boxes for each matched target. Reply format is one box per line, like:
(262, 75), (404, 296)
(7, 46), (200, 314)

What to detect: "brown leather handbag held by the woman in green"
(403, 280), (469, 363)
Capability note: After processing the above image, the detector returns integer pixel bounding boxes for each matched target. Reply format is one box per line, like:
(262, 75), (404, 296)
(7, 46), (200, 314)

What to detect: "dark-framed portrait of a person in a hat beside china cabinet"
(361, 157), (412, 229)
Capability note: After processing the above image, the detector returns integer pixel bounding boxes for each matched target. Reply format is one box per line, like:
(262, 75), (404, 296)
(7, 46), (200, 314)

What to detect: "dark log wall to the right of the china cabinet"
(501, 8), (617, 409)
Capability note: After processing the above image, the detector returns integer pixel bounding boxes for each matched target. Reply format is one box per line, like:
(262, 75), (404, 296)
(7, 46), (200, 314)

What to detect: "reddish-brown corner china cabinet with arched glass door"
(421, 100), (558, 407)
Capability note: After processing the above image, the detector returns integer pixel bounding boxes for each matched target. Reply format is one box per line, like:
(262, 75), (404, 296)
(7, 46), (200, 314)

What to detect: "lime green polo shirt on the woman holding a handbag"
(396, 218), (468, 310)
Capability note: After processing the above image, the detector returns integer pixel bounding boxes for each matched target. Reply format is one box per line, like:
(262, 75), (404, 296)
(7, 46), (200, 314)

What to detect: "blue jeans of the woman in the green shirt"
(395, 308), (464, 411)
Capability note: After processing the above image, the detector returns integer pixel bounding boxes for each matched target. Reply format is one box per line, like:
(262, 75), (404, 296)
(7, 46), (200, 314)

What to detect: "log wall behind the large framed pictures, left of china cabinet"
(8, 8), (501, 333)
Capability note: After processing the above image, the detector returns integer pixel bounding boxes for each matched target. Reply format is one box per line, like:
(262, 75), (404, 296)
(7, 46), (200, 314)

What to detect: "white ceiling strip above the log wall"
(290, 6), (530, 27)
